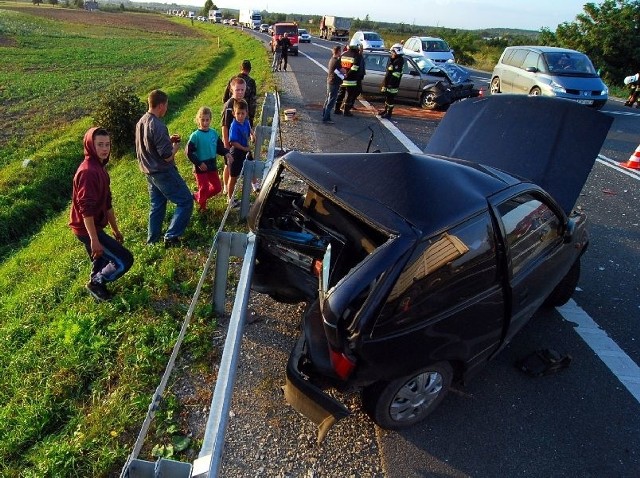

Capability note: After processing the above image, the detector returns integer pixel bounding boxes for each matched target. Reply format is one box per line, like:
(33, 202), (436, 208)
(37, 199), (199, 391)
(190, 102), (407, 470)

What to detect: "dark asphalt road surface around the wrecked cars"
(248, 28), (640, 478)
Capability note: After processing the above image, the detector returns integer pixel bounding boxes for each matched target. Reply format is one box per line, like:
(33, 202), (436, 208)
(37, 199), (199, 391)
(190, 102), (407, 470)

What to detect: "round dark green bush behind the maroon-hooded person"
(93, 86), (145, 157)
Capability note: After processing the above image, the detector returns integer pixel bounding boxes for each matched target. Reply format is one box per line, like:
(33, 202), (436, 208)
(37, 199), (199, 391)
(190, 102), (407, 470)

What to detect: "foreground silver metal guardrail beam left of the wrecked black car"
(191, 233), (256, 478)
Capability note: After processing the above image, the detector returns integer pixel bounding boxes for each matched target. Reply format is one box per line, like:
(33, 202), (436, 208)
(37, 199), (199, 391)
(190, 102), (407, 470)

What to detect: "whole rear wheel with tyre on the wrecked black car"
(362, 362), (453, 430)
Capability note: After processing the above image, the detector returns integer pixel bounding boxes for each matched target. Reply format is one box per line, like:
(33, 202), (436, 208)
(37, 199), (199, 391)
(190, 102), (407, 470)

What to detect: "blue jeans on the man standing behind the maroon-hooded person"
(147, 167), (193, 243)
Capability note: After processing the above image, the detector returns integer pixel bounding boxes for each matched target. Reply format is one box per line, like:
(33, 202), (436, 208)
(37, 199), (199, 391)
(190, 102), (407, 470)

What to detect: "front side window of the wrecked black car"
(498, 193), (563, 275)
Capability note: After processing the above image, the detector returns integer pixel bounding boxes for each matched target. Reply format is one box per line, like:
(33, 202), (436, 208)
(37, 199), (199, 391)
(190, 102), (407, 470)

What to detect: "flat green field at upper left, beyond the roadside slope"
(0, 4), (272, 260)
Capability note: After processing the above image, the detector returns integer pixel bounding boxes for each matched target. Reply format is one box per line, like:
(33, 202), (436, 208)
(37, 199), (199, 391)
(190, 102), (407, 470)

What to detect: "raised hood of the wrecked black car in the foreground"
(424, 95), (613, 214)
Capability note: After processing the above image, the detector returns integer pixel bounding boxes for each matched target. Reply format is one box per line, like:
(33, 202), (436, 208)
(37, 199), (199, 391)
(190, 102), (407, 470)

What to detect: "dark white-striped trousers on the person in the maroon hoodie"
(76, 231), (133, 284)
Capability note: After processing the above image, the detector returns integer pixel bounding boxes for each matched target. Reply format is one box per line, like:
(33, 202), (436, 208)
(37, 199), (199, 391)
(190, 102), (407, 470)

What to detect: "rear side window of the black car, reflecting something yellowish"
(376, 212), (499, 334)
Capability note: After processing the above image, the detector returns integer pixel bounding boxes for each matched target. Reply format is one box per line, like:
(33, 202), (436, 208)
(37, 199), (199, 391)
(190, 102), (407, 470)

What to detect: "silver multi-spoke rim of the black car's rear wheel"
(389, 372), (443, 422)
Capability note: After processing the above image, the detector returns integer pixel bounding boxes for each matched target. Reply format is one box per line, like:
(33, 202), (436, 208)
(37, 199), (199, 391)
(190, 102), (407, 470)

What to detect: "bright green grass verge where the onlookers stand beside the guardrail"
(0, 8), (272, 477)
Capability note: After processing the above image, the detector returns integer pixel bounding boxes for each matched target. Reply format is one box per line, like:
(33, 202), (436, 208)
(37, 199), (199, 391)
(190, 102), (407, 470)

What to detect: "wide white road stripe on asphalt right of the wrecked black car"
(557, 299), (640, 402)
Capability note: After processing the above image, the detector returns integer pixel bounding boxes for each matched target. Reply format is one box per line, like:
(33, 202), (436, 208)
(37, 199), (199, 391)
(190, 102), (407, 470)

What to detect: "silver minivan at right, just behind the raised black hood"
(491, 46), (609, 109)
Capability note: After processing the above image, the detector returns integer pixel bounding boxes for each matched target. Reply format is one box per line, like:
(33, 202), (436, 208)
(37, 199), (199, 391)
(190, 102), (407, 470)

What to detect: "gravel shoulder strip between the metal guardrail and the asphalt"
(215, 72), (384, 478)
